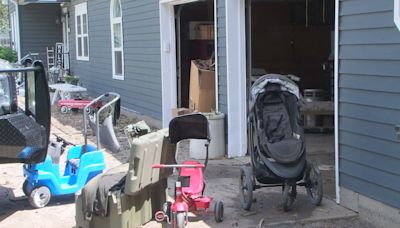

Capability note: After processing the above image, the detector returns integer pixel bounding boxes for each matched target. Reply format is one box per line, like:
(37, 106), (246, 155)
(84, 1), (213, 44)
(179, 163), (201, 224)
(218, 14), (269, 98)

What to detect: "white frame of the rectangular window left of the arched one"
(75, 2), (90, 61)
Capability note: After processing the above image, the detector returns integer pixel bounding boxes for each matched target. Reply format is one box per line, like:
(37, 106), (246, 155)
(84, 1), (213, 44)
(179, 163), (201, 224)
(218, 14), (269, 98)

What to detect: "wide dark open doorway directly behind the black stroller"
(245, 0), (336, 198)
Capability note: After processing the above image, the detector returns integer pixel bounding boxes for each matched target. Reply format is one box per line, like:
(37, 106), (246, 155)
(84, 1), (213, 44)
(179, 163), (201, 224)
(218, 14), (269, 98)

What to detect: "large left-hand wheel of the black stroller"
(239, 166), (254, 211)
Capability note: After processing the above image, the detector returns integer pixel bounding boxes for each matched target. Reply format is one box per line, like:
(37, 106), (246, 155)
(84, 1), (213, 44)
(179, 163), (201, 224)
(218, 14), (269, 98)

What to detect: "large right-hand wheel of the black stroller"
(305, 163), (324, 206)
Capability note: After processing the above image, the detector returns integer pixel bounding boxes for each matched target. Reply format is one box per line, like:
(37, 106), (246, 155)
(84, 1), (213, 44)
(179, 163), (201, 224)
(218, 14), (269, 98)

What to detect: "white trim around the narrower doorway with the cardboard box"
(160, 0), (218, 127)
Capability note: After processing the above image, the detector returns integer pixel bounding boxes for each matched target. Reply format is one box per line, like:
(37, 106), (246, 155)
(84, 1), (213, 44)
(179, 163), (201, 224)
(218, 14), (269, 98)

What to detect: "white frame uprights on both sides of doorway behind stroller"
(225, 0), (340, 203)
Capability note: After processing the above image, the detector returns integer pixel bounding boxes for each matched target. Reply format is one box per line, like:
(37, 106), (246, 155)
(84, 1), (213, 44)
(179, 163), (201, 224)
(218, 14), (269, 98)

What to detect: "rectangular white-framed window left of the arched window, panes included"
(75, 2), (89, 61)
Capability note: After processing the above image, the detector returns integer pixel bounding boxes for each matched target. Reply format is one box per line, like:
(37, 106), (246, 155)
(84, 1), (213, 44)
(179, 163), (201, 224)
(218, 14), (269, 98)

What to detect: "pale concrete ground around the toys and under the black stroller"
(0, 107), (363, 227)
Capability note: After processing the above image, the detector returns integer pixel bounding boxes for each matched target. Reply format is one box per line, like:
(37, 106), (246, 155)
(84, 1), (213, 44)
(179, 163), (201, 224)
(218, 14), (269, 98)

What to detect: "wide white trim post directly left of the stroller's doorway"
(225, 0), (247, 157)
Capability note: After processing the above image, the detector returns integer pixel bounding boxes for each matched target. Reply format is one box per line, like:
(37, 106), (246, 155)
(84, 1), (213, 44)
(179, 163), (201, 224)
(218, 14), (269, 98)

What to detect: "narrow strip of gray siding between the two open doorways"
(216, 0), (228, 113)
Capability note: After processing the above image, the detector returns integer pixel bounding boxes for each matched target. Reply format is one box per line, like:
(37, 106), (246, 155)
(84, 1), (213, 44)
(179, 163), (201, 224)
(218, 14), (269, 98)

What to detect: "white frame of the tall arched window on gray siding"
(110, 0), (125, 80)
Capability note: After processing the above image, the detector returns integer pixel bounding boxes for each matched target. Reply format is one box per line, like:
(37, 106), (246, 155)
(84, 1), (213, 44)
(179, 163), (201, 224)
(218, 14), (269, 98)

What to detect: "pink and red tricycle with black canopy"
(152, 114), (224, 228)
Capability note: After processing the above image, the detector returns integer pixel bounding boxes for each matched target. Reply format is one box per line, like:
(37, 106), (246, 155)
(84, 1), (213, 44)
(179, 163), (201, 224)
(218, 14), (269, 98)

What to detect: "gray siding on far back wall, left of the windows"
(18, 4), (63, 65)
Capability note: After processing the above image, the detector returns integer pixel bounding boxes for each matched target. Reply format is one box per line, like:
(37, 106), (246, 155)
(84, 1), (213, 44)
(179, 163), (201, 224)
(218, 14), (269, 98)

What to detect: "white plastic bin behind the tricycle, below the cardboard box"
(189, 113), (225, 159)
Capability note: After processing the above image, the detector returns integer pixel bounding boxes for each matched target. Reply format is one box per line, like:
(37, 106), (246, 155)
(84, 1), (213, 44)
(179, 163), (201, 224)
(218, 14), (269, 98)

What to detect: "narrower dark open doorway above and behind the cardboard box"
(174, 0), (215, 108)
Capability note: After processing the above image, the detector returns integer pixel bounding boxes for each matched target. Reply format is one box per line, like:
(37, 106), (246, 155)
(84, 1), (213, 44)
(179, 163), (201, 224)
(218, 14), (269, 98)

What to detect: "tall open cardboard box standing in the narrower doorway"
(189, 60), (215, 112)
